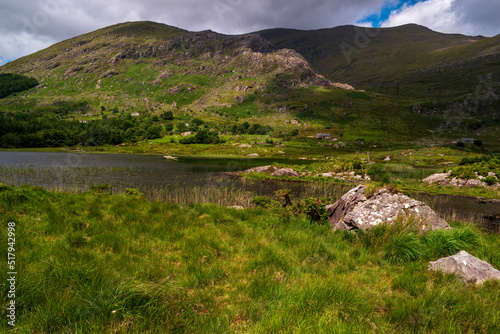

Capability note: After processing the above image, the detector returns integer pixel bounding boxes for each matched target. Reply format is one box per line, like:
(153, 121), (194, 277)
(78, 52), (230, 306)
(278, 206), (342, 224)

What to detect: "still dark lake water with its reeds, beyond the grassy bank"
(0, 151), (500, 232)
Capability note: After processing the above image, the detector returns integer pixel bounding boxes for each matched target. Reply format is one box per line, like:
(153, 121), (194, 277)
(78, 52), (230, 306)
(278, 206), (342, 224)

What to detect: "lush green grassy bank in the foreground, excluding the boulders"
(0, 186), (500, 333)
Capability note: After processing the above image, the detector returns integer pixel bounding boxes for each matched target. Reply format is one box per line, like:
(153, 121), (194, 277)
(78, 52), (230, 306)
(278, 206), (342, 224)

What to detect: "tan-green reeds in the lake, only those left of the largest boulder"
(0, 167), (352, 207)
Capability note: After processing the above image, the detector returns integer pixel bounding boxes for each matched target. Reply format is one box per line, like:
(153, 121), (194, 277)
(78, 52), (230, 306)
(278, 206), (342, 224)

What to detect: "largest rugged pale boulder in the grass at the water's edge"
(328, 186), (450, 231)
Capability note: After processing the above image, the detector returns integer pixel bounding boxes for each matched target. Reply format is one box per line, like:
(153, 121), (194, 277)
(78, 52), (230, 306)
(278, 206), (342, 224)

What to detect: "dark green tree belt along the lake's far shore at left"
(0, 111), (273, 148)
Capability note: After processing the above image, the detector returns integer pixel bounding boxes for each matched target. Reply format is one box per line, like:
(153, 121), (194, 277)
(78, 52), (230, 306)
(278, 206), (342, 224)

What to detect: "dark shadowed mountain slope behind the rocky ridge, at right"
(257, 24), (500, 100)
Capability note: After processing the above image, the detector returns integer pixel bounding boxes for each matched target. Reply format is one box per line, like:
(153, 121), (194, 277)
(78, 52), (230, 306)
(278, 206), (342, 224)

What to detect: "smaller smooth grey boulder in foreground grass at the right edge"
(429, 251), (500, 285)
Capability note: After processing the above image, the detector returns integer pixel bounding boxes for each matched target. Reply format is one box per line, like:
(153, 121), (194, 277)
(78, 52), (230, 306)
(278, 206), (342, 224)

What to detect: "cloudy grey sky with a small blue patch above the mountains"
(0, 0), (500, 65)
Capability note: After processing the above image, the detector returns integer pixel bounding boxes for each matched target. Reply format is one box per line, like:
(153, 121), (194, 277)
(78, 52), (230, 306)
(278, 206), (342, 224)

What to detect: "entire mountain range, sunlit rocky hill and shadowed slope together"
(0, 22), (500, 149)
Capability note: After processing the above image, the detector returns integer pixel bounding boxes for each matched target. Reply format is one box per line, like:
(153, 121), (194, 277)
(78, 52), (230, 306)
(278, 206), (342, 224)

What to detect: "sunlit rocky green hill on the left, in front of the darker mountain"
(0, 22), (346, 115)
